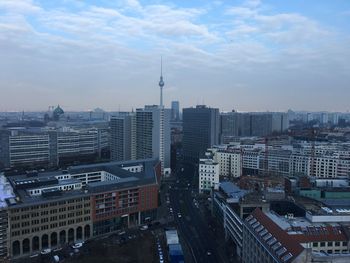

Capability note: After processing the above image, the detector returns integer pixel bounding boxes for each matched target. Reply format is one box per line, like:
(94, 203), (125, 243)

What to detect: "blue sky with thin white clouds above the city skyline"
(0, 0), (350, 111)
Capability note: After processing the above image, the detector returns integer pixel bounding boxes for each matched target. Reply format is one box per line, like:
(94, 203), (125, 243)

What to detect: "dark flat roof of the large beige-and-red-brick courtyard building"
(5, 159), (158, 206)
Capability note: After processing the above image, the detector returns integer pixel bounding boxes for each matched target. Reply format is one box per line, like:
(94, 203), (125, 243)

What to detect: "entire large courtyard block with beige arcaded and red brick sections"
(0, 159), (160, 258)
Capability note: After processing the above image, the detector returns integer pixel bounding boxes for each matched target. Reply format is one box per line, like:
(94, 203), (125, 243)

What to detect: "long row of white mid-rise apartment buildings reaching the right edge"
(208, 144), (350, 179)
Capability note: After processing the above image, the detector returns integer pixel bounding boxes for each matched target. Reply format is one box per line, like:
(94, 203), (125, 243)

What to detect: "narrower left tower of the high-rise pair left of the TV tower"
(110, 112), (136, 161)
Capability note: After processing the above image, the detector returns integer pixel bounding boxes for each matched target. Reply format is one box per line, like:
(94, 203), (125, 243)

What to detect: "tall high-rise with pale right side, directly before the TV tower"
(136, 105), (171, 173)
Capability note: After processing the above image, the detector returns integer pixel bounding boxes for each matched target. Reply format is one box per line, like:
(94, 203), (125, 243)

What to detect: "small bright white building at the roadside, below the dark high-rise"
(198, 158), (220, 193)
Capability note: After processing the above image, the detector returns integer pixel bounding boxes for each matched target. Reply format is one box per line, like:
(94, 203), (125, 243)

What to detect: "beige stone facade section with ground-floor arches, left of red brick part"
(8, 194), (92, 257)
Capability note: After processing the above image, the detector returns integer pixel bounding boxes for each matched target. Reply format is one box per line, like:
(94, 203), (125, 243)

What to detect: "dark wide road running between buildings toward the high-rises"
(168, 165), (228, 263)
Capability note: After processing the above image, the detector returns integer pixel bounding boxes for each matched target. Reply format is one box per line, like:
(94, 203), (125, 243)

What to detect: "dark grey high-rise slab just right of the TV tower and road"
(183, 105), (220, 162)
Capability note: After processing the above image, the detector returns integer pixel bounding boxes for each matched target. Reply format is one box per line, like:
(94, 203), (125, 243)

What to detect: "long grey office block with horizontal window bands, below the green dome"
(0, 128), (109, 168)
